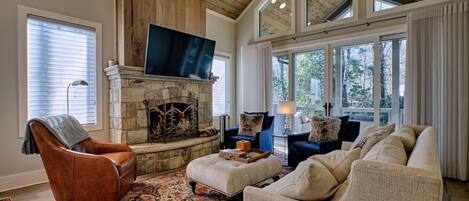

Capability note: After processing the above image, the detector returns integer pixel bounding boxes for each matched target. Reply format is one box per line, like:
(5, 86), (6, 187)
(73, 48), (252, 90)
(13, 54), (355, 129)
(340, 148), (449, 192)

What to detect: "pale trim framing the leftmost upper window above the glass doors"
(254, 0), (296, 41)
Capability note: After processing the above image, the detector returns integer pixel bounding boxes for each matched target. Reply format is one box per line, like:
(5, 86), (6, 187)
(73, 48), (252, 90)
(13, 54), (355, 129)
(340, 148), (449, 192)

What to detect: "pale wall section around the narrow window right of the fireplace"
(205, 10), (237, 126)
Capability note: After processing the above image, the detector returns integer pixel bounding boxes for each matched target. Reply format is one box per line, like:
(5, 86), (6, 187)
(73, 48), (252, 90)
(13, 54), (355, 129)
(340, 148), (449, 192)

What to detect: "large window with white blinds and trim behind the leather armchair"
(18, 6), (102, 134)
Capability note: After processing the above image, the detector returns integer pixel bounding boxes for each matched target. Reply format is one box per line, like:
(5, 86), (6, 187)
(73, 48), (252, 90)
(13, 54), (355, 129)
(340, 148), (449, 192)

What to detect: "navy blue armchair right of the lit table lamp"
(288, 121), (360, 168)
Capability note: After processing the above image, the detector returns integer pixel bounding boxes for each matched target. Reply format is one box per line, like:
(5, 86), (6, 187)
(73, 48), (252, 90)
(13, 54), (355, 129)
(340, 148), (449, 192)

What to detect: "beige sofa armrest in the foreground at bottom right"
(344, 160), (443, 201)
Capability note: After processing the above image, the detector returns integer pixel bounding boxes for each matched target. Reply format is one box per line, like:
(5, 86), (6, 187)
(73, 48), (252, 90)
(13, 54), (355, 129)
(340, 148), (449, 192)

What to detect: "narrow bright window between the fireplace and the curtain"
(212, 55), (230, 116)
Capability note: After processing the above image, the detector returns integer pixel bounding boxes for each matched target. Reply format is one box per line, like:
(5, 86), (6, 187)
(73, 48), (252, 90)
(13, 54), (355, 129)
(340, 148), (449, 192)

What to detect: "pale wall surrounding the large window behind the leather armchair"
(0, 0), (116, 191)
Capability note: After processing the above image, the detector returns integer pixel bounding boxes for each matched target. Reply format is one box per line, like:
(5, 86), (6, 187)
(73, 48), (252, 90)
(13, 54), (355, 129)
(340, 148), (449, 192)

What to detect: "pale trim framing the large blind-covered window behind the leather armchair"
(17, 5), (103, 137)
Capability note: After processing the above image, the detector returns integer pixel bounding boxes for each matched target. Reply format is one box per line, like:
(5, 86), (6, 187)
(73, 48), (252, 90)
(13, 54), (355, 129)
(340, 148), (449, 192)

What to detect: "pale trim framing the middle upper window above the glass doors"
(300, 0), (359, 32)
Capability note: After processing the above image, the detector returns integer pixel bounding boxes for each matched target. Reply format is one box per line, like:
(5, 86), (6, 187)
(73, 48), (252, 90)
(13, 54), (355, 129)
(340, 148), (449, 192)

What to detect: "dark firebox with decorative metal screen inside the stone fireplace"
(143, 96), (198, 143)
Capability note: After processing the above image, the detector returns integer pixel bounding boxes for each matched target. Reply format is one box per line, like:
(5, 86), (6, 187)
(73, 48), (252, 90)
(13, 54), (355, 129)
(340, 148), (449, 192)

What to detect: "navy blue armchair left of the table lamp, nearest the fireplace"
(224, 116), (274, 153)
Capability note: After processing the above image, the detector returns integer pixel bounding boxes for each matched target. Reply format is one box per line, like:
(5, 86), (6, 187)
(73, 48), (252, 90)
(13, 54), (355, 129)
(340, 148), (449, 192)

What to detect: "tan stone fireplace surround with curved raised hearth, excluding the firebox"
(105, 65), (219, 175)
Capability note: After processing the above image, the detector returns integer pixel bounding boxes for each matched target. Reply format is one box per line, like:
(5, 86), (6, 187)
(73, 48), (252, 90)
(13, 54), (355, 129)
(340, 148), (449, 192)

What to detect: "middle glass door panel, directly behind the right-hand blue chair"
(333, 43), (375, 128)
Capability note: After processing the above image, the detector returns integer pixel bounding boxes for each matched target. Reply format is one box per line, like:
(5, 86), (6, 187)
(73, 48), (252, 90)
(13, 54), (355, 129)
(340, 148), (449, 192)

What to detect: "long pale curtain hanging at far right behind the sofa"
(404, 0), (469, 180)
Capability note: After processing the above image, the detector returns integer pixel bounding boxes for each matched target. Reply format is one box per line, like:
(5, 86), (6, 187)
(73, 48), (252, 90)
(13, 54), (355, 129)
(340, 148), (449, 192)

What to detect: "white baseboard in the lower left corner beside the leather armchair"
(0, 169), (49, 192)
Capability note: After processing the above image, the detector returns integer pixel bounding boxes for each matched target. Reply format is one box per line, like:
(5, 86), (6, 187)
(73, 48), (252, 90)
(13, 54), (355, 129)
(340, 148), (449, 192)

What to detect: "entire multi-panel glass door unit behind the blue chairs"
(278, 35), (405, 131)
